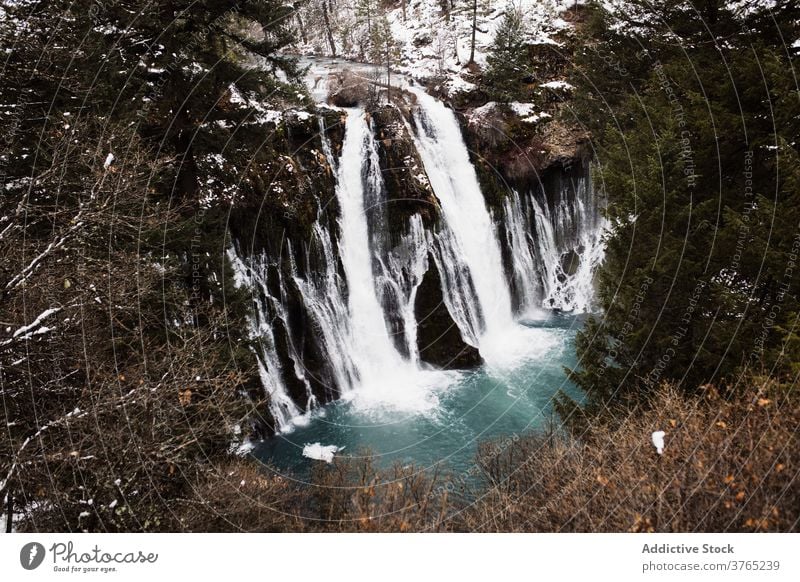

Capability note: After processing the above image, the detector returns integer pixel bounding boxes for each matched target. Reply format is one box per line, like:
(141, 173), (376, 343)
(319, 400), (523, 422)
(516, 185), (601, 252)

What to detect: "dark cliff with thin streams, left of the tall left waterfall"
(228, 109), (346, 424)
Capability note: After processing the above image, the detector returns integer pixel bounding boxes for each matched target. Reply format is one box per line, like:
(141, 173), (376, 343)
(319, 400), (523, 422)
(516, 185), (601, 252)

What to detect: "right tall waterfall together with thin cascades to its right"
(409, 87), (602, 368)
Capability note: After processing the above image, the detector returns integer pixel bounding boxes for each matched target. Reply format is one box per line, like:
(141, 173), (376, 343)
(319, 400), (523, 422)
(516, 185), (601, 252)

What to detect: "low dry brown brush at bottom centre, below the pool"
(164, 454), (447, 532)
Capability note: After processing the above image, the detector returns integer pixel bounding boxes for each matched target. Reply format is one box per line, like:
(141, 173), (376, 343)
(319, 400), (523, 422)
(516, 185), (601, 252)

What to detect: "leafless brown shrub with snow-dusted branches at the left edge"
(0, 121), (260, 531)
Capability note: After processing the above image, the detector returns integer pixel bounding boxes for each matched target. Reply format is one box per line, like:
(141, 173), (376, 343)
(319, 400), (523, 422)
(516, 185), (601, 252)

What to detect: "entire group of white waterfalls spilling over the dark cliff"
(228, 75), (603, 432)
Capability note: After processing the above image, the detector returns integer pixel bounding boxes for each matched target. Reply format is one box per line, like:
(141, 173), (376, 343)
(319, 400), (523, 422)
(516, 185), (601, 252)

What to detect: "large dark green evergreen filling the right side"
(561, 1), (800, 420)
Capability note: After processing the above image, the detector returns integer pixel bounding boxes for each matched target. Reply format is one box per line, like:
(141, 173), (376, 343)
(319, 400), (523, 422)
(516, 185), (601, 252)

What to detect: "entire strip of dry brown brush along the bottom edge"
(166, 382), (800, 532)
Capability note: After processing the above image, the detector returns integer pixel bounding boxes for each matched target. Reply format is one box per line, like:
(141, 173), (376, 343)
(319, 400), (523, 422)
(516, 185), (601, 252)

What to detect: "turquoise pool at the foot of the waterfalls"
(253, 312), (583, 479)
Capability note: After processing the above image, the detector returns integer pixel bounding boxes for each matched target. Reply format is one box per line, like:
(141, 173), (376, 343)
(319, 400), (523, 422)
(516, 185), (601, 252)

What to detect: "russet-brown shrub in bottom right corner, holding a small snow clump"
(459, 381), (800, 532)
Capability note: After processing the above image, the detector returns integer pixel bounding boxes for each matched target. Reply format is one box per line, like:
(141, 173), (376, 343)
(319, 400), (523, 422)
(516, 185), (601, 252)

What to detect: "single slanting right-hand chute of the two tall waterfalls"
(410, 88), (513, 348)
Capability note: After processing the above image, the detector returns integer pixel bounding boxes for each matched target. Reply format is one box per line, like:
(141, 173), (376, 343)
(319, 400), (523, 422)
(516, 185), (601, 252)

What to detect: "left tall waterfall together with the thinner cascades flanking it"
(228, 109), (459, 432)
